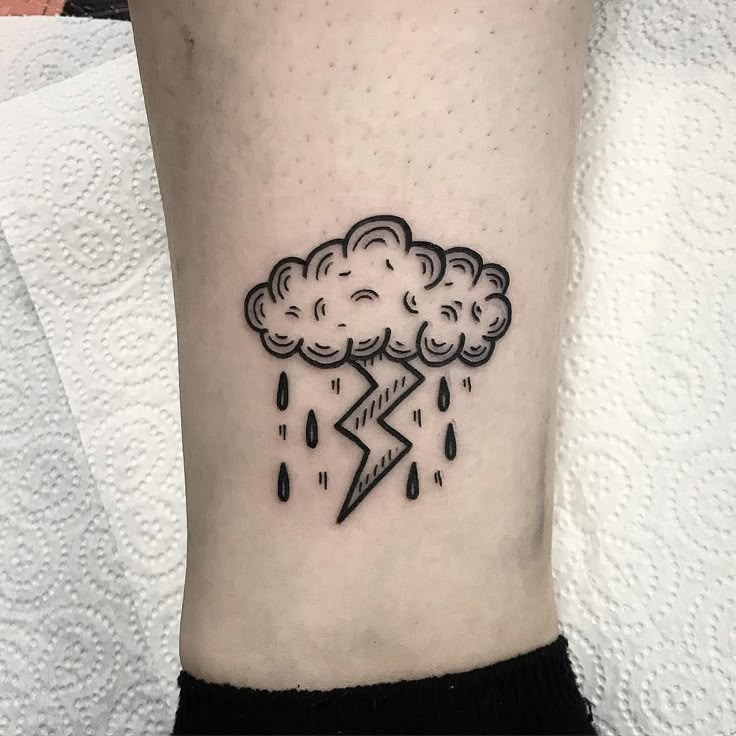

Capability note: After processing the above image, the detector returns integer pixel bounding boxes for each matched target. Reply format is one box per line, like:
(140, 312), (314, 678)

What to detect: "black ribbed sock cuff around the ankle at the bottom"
(174, 636), (595, 734)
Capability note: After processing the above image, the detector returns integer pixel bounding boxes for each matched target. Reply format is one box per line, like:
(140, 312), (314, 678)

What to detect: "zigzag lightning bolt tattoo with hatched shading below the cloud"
(335, 355), (424, 524)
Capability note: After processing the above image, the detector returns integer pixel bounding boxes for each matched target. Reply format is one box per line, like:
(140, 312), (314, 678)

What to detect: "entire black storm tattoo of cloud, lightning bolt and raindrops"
(245, 215), (511, 523)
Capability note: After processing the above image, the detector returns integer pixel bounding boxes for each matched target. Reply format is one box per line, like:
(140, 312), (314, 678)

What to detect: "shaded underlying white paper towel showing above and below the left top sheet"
(0, 18), (170, 736)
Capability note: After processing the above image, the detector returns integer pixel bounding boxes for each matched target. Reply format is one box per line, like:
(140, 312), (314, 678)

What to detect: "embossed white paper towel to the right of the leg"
(554, 0), (736, 734)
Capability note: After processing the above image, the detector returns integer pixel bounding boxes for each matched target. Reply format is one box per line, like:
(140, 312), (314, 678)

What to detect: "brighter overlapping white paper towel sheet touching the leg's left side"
(0, 46), (185, 708)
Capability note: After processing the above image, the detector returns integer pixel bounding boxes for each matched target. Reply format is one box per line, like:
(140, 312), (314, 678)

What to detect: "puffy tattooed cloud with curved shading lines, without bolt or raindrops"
(245, 215), (511, 368)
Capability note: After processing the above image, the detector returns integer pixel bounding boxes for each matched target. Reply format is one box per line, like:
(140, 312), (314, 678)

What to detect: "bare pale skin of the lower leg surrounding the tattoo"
(131, 0), (589, 689)
